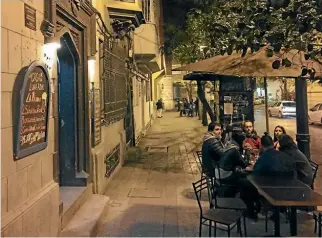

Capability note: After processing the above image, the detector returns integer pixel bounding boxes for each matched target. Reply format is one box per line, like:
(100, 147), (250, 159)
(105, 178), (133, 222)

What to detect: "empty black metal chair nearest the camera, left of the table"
(192, 178), (243, 237)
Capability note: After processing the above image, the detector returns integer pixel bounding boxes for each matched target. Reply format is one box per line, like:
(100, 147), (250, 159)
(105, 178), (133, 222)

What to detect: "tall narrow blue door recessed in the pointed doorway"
(57, 33), (87, 186)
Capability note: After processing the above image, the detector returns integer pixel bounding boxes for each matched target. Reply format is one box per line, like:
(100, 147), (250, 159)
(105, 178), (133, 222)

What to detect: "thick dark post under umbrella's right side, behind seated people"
(295, 77), (311, 159)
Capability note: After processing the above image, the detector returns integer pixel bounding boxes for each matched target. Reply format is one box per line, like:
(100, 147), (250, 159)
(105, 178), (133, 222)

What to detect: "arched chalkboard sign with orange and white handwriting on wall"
(13, 61), (50, 160)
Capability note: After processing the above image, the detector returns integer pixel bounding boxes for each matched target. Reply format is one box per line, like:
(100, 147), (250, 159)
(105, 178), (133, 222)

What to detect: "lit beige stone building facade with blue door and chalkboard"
(1, 0), (162, 236)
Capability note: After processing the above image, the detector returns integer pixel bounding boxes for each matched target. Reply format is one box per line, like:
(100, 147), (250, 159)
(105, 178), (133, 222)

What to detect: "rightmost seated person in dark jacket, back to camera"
(279, 135), (313, 186)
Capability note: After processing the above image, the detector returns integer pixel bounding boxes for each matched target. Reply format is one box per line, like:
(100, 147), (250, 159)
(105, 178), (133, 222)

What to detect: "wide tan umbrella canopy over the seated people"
(173, 47), (322, 78)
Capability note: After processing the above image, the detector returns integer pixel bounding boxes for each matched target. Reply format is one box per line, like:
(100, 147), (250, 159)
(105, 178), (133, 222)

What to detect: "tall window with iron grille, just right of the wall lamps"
(100, 35), (128, 125)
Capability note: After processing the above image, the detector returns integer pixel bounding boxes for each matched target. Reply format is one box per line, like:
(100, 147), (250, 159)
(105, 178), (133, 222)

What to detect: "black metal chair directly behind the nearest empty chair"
(207, 174), (247, 237)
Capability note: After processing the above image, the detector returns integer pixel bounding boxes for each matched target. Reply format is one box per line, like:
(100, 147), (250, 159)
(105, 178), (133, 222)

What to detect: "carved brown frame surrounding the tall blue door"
(43, 0), (96, 186)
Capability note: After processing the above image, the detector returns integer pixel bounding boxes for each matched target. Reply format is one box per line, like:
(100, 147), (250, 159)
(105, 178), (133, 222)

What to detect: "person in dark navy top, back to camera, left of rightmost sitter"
(253, 133), (295, 177)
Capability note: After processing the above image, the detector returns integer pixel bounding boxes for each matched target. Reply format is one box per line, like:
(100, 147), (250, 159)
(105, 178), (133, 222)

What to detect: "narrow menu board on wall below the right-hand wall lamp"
(92, 89), (101, 146)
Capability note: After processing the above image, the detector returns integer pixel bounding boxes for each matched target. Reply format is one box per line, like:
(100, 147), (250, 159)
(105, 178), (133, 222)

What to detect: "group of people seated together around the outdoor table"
(202, 121), (313, 220)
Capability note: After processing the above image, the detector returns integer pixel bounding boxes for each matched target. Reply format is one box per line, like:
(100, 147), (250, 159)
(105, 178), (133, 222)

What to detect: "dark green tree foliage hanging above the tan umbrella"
(173, 0), (322, 76)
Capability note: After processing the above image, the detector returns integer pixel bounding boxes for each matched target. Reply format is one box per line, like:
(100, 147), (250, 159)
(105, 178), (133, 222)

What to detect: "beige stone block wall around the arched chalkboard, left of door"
(1, 0), (59, 236)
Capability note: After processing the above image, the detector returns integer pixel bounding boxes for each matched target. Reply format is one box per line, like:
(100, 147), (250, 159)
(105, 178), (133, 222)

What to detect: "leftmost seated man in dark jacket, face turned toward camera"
(202, 122), (260, 218)
